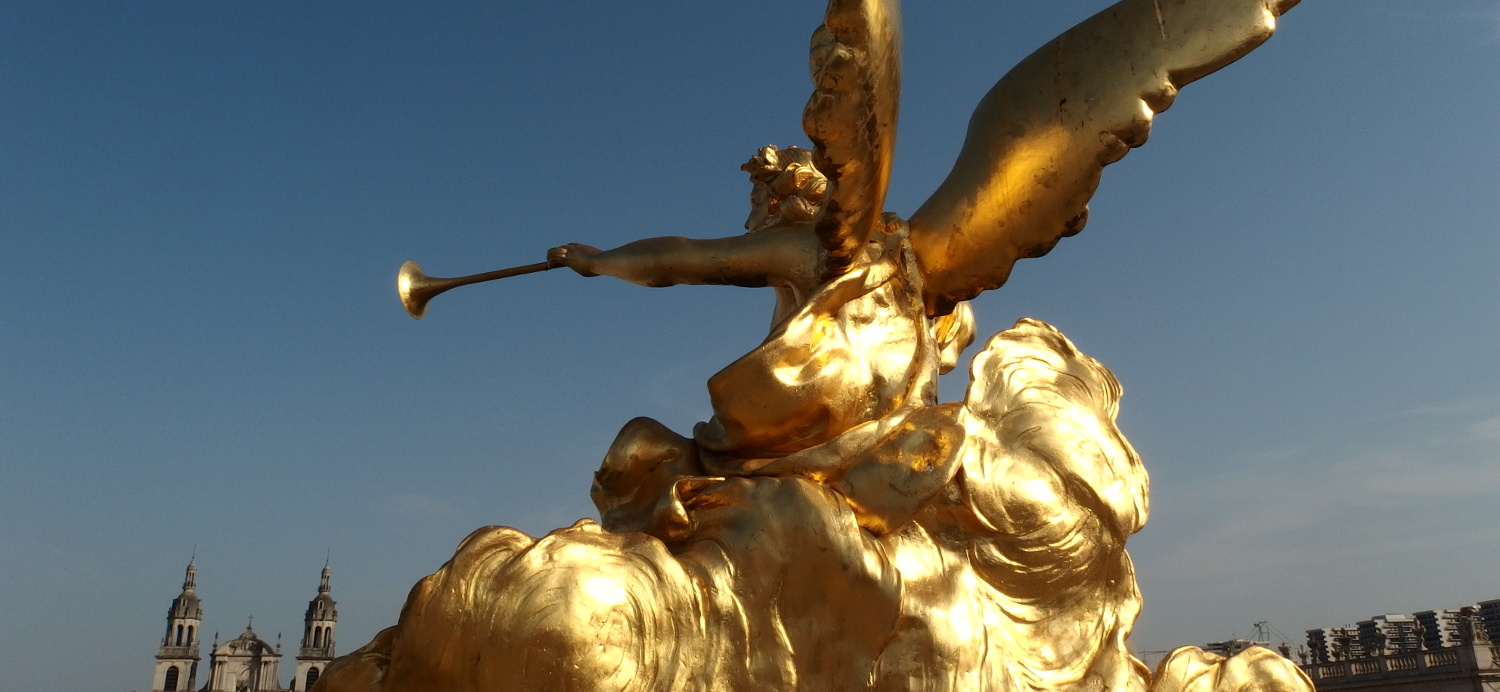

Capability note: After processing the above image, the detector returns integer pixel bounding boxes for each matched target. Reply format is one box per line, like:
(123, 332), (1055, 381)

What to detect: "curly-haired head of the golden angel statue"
(740, 146), (828, 233)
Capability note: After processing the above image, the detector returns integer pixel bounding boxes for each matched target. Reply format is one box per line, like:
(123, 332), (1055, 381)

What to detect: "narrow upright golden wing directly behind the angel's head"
(803, 0), (902, 278)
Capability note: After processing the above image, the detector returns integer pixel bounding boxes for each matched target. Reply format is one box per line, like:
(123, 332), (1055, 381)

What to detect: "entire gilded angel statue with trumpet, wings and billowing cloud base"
(325, 0), (1313, 692)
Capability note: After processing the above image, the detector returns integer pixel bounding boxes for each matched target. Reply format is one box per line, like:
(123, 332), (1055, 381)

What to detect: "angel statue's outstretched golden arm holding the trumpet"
(548, 228), (824, 288)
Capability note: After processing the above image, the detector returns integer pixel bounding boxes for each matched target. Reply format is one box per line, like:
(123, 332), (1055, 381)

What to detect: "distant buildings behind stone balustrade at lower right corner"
(1298, 600), (1500, 692)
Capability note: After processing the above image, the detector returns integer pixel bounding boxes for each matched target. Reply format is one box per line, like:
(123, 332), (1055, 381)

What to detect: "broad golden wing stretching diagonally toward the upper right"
(911, 0), (1299, 314)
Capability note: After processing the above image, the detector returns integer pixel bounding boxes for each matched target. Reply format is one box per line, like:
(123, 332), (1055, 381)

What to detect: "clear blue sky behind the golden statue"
(0, 0), (1500, 692)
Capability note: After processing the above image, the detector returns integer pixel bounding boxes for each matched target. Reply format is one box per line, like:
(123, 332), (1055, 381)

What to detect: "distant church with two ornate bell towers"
(152, 561), (339, 692)
